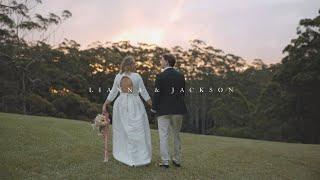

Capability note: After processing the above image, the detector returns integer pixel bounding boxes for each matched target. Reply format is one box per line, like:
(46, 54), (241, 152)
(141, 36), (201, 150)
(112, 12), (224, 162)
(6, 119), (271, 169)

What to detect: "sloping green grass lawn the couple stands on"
(0, 113), (320, 180)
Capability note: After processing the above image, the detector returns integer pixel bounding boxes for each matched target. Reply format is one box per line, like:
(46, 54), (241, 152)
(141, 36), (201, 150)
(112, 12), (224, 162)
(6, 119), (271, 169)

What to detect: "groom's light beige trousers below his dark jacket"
(157, 114), (183, 165)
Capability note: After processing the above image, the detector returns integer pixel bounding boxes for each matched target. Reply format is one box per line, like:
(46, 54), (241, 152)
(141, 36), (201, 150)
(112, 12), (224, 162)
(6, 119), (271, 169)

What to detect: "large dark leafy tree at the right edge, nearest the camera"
(274, 10), (320, 143)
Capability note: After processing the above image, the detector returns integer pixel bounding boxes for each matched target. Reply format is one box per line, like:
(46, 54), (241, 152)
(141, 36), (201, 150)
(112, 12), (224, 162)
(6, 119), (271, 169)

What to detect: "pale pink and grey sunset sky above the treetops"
(36, 0), (320, 64)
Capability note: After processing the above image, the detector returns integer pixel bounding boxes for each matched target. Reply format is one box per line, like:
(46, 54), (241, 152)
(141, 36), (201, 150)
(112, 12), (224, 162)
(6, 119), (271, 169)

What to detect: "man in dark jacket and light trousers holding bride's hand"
(151, 54), (187, 168)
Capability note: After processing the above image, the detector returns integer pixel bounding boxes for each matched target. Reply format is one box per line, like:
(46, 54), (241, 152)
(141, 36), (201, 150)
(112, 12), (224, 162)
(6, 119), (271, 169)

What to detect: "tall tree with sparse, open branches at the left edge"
(0, 0), (71, 113)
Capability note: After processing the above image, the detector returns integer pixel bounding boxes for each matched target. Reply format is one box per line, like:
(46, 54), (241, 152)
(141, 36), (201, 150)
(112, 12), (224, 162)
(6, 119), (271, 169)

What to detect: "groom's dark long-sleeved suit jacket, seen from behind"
(152, 68), (187, 116)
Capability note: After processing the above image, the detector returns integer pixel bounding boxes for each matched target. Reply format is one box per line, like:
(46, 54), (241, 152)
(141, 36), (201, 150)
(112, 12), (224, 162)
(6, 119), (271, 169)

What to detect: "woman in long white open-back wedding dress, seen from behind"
(102, 56), (152, 166)
